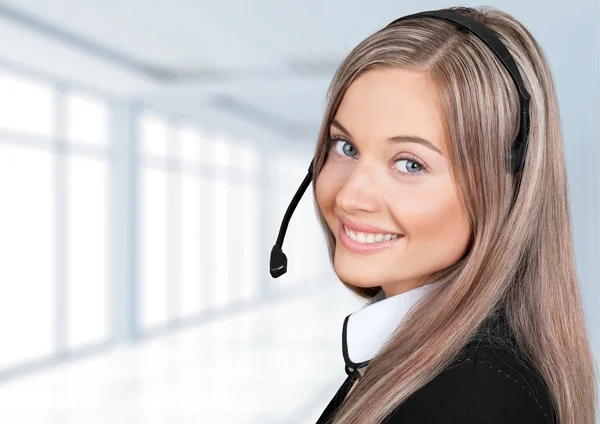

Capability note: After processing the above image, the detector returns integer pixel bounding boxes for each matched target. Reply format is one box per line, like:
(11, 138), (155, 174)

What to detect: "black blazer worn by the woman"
(317, 315), (557, 424)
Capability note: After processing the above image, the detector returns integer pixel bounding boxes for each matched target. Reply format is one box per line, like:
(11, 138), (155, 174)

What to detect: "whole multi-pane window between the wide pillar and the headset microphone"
(139, 111), (266, 331)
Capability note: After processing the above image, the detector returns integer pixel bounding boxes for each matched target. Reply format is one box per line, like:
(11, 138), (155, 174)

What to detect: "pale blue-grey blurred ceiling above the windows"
(0, 0), (440, 141)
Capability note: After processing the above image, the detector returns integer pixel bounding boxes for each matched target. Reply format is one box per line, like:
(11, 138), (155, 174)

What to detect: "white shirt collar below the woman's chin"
(342, 282), (441, 372)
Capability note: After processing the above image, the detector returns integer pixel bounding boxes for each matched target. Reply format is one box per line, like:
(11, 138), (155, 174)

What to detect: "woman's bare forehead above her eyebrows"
(335, 68), (445, 151)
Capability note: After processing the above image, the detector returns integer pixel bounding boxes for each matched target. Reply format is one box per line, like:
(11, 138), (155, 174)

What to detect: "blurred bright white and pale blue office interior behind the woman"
(0, 0), (600, 424)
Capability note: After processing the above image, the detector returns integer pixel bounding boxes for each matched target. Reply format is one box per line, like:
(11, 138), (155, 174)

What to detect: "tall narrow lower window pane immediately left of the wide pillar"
(66, 157), (110, 349)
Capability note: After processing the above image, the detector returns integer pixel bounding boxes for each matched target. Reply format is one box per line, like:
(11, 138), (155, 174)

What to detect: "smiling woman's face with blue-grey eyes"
(315, 69), (470, 297)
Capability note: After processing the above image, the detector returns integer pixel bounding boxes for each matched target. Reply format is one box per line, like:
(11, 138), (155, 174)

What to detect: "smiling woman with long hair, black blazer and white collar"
(304, 7), (595, 424)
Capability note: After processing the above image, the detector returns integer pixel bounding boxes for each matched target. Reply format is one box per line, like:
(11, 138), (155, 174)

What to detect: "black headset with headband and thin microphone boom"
(269, 10), (530, 278)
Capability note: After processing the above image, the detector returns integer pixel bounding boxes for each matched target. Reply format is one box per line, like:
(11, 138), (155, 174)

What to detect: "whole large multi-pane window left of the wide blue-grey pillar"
(0, 69), (112, 371)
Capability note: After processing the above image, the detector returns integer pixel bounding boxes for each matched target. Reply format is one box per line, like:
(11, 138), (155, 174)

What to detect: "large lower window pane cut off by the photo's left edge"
(0, 143), (58, 370)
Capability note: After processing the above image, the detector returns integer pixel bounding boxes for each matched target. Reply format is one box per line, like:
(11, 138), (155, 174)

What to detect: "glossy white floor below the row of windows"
(0, 280), (363, 424)
